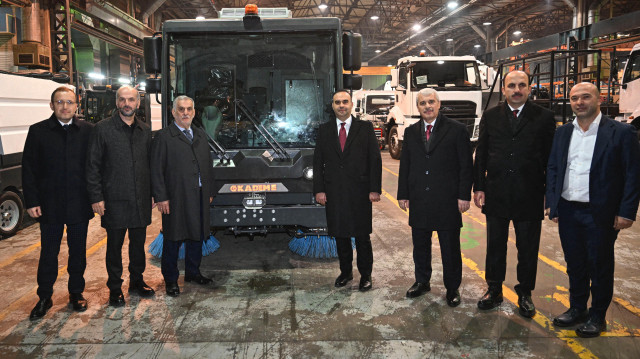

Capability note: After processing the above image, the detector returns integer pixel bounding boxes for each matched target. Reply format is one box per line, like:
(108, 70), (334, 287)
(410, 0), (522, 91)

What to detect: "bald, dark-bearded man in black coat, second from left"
(87, 86), (155, 307)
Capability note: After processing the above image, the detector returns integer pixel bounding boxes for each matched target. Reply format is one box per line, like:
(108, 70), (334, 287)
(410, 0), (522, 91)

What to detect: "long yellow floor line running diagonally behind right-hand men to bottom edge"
(382, 190), (600, 358)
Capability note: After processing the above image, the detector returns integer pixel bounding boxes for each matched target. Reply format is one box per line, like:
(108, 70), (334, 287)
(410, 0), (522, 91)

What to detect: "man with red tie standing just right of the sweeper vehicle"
(313, 90), (382, 292)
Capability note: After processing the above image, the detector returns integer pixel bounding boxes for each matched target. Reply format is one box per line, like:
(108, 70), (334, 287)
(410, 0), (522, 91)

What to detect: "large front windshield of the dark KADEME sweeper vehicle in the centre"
(170, 32), (336, 149)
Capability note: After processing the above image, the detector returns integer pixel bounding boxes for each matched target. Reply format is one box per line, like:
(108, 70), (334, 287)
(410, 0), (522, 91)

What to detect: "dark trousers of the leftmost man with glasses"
(37, 221), (89, 299)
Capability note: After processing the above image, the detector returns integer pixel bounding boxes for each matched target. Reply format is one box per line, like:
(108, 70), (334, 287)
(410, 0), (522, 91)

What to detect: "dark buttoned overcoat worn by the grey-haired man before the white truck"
(398, 114), (473, 230)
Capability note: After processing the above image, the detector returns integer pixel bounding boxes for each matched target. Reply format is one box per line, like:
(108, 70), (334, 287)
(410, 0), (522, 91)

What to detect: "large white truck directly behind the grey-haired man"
(385, 56), (482, 159)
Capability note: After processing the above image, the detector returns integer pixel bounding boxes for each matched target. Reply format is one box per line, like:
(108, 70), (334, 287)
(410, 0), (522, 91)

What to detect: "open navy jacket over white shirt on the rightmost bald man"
(547, 116), (640, 227)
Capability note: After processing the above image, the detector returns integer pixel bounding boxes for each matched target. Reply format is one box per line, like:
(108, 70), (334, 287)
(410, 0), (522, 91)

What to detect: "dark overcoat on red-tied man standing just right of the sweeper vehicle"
(313, 117), (382, 237)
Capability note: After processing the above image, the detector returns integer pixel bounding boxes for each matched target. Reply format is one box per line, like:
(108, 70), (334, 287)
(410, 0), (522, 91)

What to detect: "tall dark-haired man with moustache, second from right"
(473, 71), (556, 318)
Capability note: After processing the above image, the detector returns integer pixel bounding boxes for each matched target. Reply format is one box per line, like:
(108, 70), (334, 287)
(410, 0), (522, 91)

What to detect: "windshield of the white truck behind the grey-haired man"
(411, 61), (480, 90)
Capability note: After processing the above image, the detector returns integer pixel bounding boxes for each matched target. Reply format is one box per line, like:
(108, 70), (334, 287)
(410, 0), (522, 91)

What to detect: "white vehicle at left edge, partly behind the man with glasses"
(0, 73), (75, 237)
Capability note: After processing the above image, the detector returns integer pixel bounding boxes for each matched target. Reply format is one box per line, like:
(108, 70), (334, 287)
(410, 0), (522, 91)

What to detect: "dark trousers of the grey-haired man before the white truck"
(411, 227), (462, 291)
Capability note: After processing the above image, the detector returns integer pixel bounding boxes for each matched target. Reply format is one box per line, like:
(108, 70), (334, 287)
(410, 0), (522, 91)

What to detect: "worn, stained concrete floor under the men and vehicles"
(0, 151), (640, 358)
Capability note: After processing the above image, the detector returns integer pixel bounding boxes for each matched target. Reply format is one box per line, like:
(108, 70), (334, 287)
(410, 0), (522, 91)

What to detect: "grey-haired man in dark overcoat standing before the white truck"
(398, 89), (473, 307)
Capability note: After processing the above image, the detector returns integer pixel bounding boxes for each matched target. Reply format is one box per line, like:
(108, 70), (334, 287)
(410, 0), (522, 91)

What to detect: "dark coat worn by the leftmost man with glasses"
(22, 115), (93, 224)
